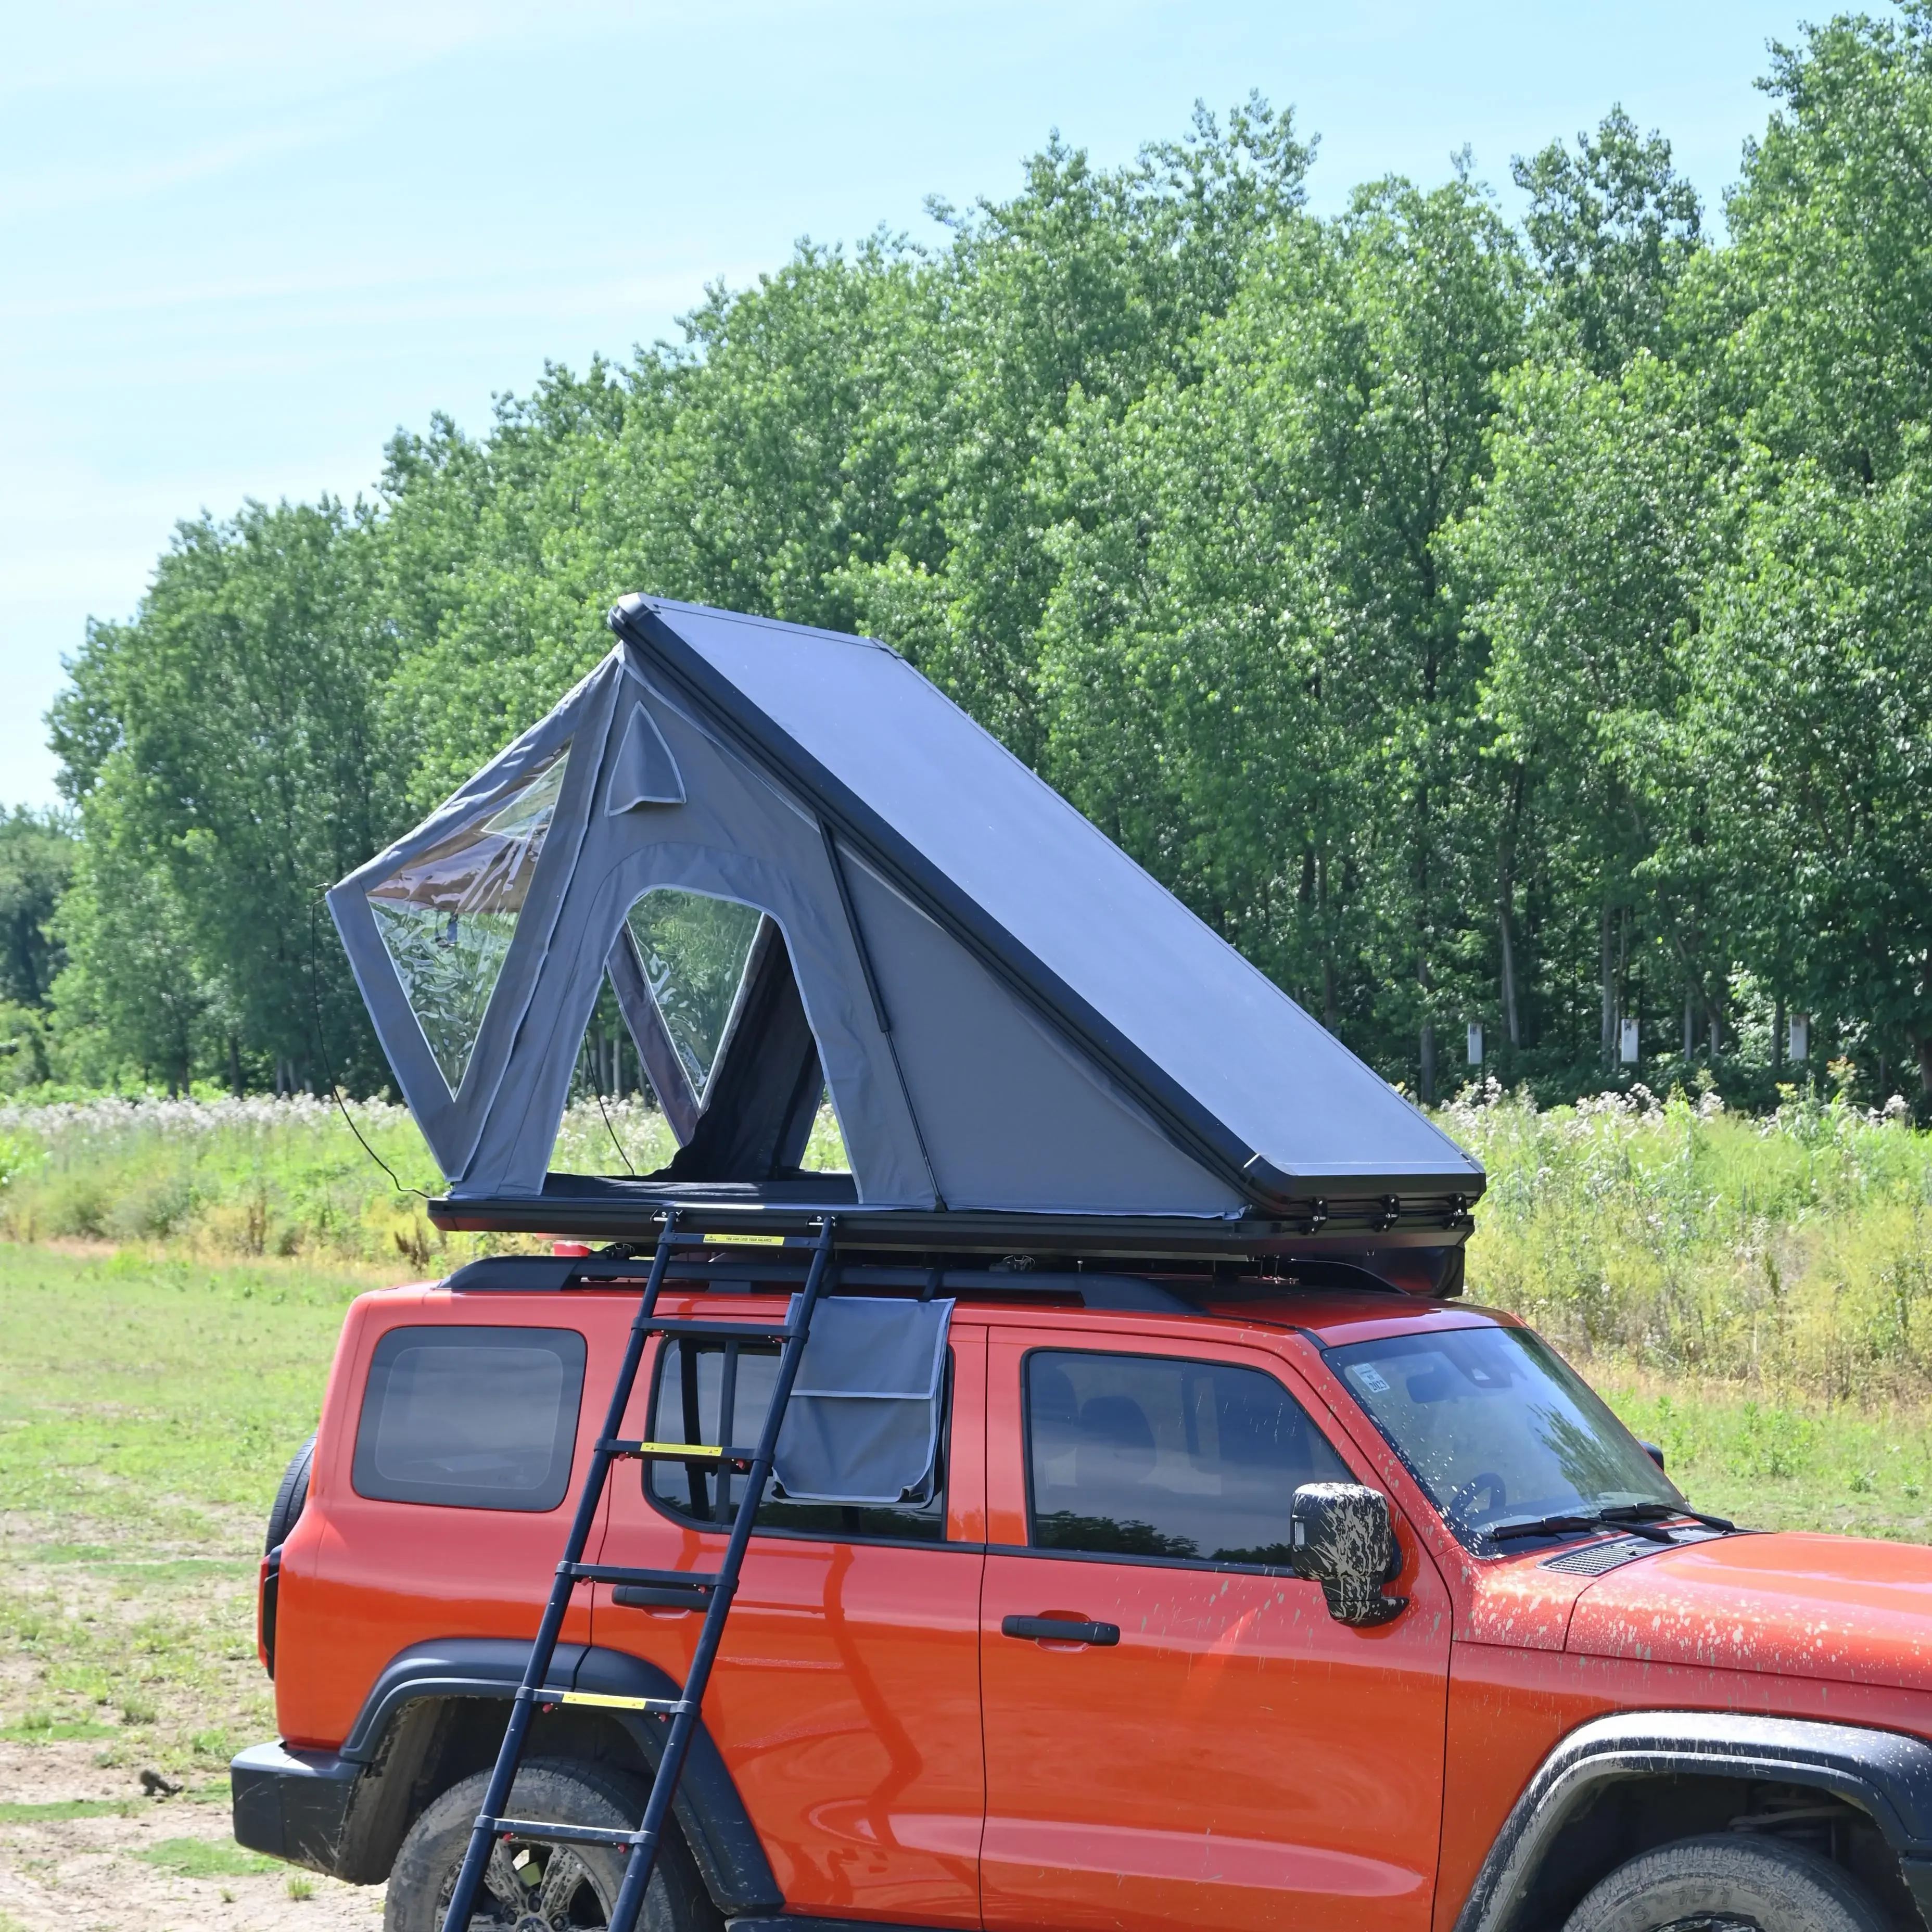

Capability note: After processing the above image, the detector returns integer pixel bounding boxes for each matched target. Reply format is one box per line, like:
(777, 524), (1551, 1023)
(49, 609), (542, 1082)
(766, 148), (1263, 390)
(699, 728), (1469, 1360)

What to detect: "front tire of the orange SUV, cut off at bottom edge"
(1563, 1832), (1889, 1932)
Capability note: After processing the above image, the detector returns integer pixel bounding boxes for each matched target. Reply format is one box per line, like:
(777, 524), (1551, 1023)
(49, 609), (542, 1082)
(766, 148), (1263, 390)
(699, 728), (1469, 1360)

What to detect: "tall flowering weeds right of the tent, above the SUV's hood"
(1439, 1082), (1932, 1399)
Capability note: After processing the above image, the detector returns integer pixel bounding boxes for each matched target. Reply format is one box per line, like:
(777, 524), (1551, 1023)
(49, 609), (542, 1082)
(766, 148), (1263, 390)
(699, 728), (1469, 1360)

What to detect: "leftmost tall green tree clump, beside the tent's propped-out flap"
(52, 502), (400, 1084)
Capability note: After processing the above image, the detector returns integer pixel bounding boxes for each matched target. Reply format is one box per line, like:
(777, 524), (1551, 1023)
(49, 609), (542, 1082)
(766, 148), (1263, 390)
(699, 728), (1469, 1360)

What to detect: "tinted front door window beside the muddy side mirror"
(1026, 1349), (1351, 1567)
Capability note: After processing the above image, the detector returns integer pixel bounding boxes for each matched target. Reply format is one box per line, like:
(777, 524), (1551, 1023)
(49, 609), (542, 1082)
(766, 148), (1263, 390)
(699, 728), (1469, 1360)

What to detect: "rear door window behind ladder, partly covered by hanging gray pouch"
(643, 1337), (952, 1544)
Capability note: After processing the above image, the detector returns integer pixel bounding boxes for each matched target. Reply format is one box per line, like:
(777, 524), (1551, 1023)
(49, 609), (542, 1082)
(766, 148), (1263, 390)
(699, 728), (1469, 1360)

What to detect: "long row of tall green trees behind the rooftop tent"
(11, 11), (1932, 1105)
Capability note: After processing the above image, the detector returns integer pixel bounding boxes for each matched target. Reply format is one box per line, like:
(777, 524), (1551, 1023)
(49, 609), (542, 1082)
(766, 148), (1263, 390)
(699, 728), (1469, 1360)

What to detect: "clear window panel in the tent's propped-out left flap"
(369, 744), (570, 1094)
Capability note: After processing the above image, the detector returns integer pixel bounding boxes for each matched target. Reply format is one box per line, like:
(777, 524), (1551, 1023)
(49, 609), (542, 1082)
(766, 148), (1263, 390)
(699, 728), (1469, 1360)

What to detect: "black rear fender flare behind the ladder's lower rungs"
(338, 1636), (784, 1913)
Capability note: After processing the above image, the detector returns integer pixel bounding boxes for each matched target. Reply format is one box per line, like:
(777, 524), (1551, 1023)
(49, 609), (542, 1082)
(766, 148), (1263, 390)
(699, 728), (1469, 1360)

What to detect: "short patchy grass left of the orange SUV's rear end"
(0, 1246), (365, 1775)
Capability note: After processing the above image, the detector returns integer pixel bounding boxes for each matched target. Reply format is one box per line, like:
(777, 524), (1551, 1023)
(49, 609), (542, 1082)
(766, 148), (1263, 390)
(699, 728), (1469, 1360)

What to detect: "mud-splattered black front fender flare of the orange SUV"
(1455, 1710), (1932, 1932)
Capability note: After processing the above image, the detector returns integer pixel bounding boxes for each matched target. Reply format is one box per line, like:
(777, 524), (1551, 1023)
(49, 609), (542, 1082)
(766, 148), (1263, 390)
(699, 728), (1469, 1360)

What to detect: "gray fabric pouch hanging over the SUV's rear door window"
(773, 1294), (952, 1503)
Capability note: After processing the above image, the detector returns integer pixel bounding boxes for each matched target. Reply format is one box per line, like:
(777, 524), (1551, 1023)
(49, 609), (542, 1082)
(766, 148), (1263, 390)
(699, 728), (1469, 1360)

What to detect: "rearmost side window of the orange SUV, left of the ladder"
(352, 1327), (583, 1509)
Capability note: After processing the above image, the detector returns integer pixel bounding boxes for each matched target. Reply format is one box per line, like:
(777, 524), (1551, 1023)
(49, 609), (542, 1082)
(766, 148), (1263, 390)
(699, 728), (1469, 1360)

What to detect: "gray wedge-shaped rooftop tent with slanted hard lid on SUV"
(328, 597), (1484, 1244)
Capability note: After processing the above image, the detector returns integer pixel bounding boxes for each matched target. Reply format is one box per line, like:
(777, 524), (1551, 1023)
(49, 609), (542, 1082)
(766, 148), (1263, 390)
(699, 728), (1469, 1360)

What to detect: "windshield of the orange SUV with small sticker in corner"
(1327, 1327), (1683, 1553)
